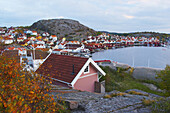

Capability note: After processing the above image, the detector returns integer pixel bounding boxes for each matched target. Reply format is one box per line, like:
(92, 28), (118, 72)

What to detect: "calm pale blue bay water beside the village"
(92, 47), (170, 69)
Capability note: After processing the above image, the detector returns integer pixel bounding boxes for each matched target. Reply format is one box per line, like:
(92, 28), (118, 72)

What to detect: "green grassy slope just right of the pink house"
(101, 66), (165, 96)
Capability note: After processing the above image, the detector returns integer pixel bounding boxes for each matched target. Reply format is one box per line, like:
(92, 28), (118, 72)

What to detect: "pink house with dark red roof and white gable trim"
(36, 54), (106, 92)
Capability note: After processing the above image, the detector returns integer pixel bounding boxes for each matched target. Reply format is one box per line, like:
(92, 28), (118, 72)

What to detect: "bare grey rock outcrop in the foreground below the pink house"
(48, 85), (165, 113)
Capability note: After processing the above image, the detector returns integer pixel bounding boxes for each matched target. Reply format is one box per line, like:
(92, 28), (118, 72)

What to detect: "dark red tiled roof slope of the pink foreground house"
(36, 54), (88, 83)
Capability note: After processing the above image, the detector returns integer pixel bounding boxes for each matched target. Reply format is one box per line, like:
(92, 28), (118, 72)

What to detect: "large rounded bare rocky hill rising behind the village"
(30, 19), (96, 39)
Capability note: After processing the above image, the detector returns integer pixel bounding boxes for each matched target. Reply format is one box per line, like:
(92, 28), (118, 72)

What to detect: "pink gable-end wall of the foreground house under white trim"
(74, 64), (98, 92)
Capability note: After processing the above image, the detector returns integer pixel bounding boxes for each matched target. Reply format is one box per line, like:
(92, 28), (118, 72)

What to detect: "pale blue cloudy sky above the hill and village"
(0, 0), (170, 33)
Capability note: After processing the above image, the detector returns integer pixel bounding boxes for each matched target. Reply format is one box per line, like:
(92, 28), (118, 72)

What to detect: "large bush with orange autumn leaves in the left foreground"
(0, 56), (65, 113)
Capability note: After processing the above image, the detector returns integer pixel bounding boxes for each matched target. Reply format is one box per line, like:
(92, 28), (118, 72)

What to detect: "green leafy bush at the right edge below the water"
(157, 65), (170, 96)
